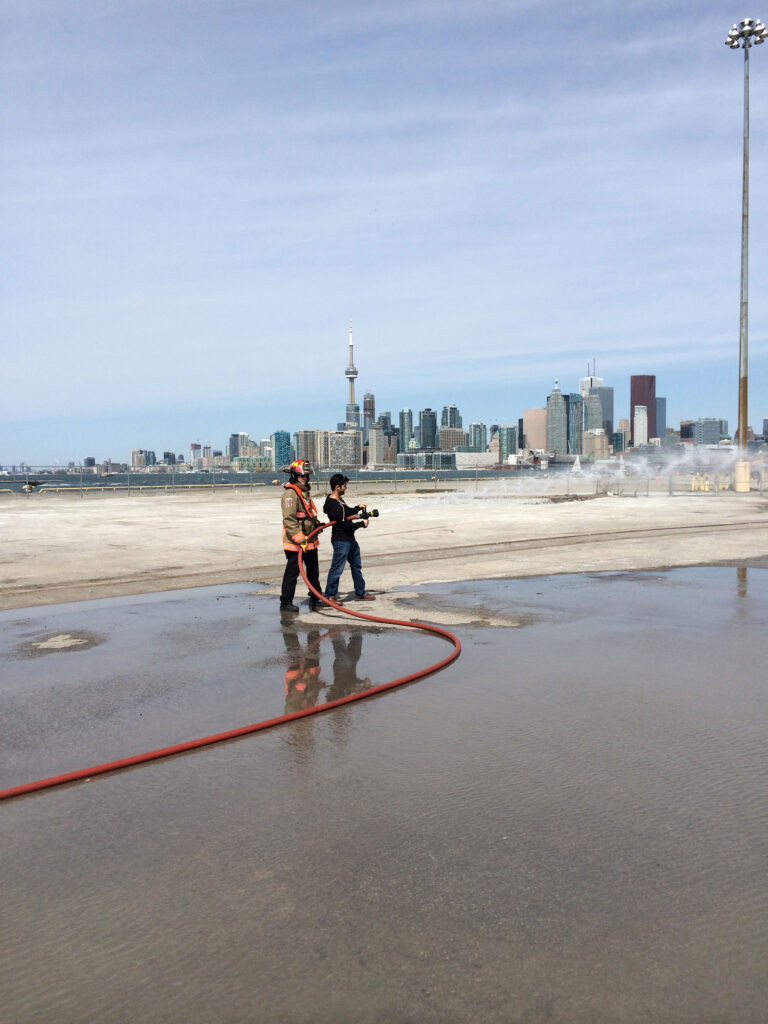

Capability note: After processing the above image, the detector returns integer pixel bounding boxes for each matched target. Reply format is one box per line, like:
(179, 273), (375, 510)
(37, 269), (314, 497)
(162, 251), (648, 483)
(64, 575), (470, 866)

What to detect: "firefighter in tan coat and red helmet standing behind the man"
(280, 459), (321, 611)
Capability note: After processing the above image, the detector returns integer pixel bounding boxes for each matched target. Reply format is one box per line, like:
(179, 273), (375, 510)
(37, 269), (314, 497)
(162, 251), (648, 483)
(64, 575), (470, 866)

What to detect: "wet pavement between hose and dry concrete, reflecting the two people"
(0, 585), (441, 788)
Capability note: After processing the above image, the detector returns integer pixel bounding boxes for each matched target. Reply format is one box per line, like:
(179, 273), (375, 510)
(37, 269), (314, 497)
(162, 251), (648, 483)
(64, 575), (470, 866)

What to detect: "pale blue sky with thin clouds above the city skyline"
(0, 0), (768, 466)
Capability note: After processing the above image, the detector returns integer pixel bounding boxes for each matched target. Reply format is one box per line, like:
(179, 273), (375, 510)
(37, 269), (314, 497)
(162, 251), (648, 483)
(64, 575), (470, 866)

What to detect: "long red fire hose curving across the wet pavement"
(0, 522), (462, 800)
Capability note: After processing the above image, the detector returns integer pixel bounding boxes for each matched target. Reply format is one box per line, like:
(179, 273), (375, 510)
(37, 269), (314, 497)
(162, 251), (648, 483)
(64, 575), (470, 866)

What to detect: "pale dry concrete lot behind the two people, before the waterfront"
(0, 479), (768, 608)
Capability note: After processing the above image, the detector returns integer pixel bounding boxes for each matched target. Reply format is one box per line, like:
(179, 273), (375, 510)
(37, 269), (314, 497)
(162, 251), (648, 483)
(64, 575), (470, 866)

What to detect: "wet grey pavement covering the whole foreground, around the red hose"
(0, 568), (768, 1024)
